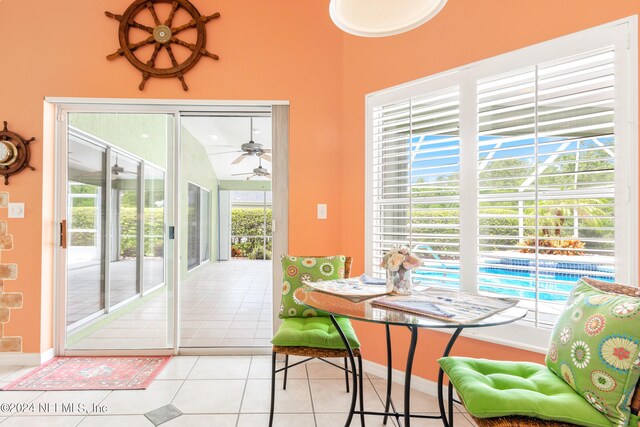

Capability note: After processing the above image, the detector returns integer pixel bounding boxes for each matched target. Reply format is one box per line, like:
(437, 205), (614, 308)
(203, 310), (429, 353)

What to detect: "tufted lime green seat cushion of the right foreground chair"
(438, 357), (611, 427)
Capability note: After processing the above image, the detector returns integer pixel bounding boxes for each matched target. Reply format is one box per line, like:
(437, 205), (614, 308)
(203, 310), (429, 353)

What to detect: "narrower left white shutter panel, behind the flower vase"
(372, 88), (460, 287)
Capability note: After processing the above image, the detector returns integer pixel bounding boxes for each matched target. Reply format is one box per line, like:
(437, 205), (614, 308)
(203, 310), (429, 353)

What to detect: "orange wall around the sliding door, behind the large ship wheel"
(0, 0), (342, 352)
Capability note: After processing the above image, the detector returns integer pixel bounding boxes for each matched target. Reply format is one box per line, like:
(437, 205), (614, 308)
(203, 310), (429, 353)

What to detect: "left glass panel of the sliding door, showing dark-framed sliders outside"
(61, 112), (175, 351)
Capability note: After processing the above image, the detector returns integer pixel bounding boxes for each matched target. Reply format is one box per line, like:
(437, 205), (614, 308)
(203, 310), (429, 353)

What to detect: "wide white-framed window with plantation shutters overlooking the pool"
(366, 21), (638, 334)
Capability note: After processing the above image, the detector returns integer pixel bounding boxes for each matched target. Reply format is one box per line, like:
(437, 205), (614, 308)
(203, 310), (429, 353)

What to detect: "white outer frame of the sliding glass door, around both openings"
(53, 97), (289, 356)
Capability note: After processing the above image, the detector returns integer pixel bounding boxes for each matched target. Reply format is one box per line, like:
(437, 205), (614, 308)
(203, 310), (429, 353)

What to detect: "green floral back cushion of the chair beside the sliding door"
(280, 255), (347, 319)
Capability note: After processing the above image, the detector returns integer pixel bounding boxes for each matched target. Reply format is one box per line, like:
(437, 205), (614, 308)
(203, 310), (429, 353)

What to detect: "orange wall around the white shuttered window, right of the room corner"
(342, 0), (640, 380)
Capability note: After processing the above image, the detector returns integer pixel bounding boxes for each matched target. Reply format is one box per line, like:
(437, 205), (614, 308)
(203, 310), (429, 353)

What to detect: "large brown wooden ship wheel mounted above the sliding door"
(105, 0), (220, 91)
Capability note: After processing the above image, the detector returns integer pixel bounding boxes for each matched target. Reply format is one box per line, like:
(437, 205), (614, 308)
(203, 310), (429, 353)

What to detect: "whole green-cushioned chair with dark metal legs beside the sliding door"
(269, 256), (362, 426)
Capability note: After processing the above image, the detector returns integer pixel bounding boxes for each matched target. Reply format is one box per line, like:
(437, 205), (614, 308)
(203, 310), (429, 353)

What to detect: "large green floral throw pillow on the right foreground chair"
(546, 279), (640, 427)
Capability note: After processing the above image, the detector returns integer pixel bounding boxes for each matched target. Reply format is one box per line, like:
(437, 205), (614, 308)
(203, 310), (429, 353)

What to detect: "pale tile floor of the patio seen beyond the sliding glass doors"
(71, 260), (273, 350)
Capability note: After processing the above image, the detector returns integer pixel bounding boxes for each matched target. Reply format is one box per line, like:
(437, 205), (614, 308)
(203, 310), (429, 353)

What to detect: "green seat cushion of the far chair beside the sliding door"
(271, 317), (360, 350)
